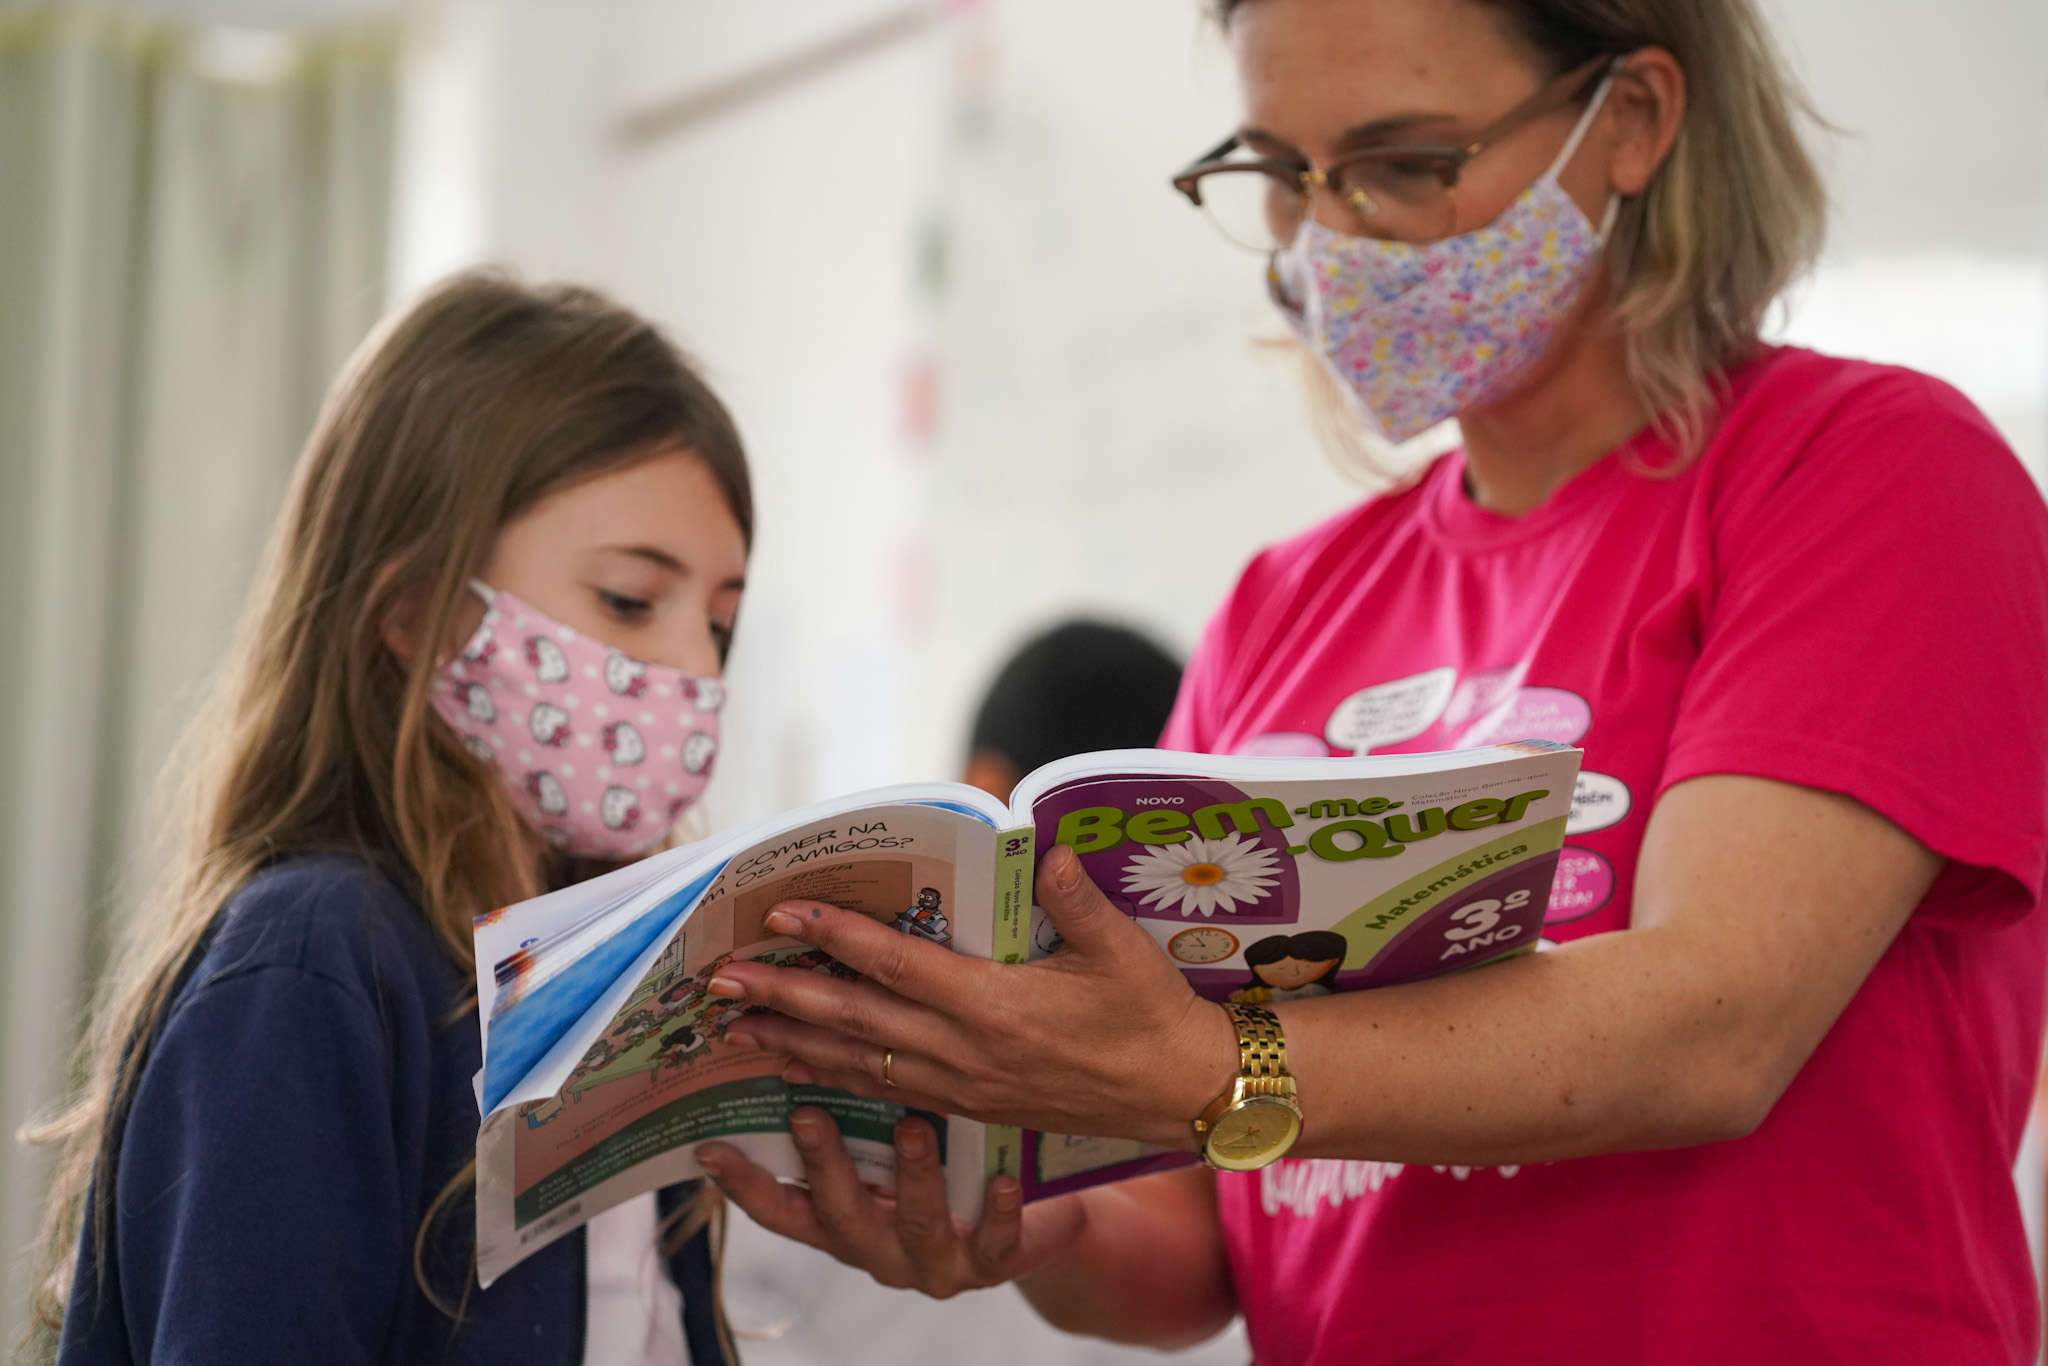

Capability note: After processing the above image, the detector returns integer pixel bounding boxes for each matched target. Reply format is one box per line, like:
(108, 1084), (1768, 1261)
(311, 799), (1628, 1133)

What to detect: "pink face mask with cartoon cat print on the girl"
(428, 582), (725, 858)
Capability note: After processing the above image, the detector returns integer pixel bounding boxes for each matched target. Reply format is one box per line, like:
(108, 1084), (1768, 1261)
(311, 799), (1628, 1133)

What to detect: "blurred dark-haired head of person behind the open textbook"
(965, 621), (1180, 801)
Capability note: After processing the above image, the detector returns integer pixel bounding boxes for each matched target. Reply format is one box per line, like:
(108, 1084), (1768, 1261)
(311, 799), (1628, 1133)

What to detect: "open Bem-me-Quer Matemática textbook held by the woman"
(475, 741), (1579, 1284)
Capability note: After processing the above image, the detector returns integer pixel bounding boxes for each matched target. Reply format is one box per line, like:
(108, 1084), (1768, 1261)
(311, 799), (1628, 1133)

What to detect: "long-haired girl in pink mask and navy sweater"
(39, 274), (754, 1366)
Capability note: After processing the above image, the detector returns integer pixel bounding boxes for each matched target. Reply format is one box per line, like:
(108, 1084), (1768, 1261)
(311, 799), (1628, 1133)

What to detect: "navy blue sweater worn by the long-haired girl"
(57, 854), (723, 1366)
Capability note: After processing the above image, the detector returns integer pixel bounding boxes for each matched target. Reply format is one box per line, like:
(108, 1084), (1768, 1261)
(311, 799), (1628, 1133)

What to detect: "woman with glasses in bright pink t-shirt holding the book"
(702, 0), (2048, 1366)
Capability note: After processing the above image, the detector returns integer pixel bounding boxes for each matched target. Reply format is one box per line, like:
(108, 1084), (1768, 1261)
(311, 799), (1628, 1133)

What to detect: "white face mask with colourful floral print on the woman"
(1266, 76), (1620, 442)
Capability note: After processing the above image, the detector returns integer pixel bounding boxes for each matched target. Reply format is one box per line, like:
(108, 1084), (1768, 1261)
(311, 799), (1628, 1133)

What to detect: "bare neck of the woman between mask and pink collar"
(1458, 279), (1651, 516)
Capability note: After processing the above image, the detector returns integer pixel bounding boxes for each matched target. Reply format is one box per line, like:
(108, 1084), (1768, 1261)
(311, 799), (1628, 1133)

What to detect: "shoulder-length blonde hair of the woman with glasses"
(1217, 0), (1827, 463)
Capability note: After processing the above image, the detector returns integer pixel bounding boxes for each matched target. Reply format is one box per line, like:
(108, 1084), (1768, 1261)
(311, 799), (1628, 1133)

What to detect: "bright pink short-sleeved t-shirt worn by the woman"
(1163, 350), (2048, 1366)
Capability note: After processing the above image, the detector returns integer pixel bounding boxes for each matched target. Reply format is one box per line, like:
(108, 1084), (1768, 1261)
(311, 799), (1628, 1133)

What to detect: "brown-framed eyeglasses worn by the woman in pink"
(1174, 53), (1618, 252)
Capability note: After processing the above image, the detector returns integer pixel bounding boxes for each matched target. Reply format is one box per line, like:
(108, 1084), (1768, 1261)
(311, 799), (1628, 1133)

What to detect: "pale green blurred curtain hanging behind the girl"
(0, 6), (397, 1348)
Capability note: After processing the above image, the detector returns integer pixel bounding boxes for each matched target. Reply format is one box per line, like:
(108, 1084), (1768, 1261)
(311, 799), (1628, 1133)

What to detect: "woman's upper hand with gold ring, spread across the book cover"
(711, 846), (1237, 1151)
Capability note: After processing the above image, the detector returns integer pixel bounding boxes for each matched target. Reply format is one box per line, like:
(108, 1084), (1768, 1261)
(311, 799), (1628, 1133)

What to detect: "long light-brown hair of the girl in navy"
(25, 272), (754, 1339)
